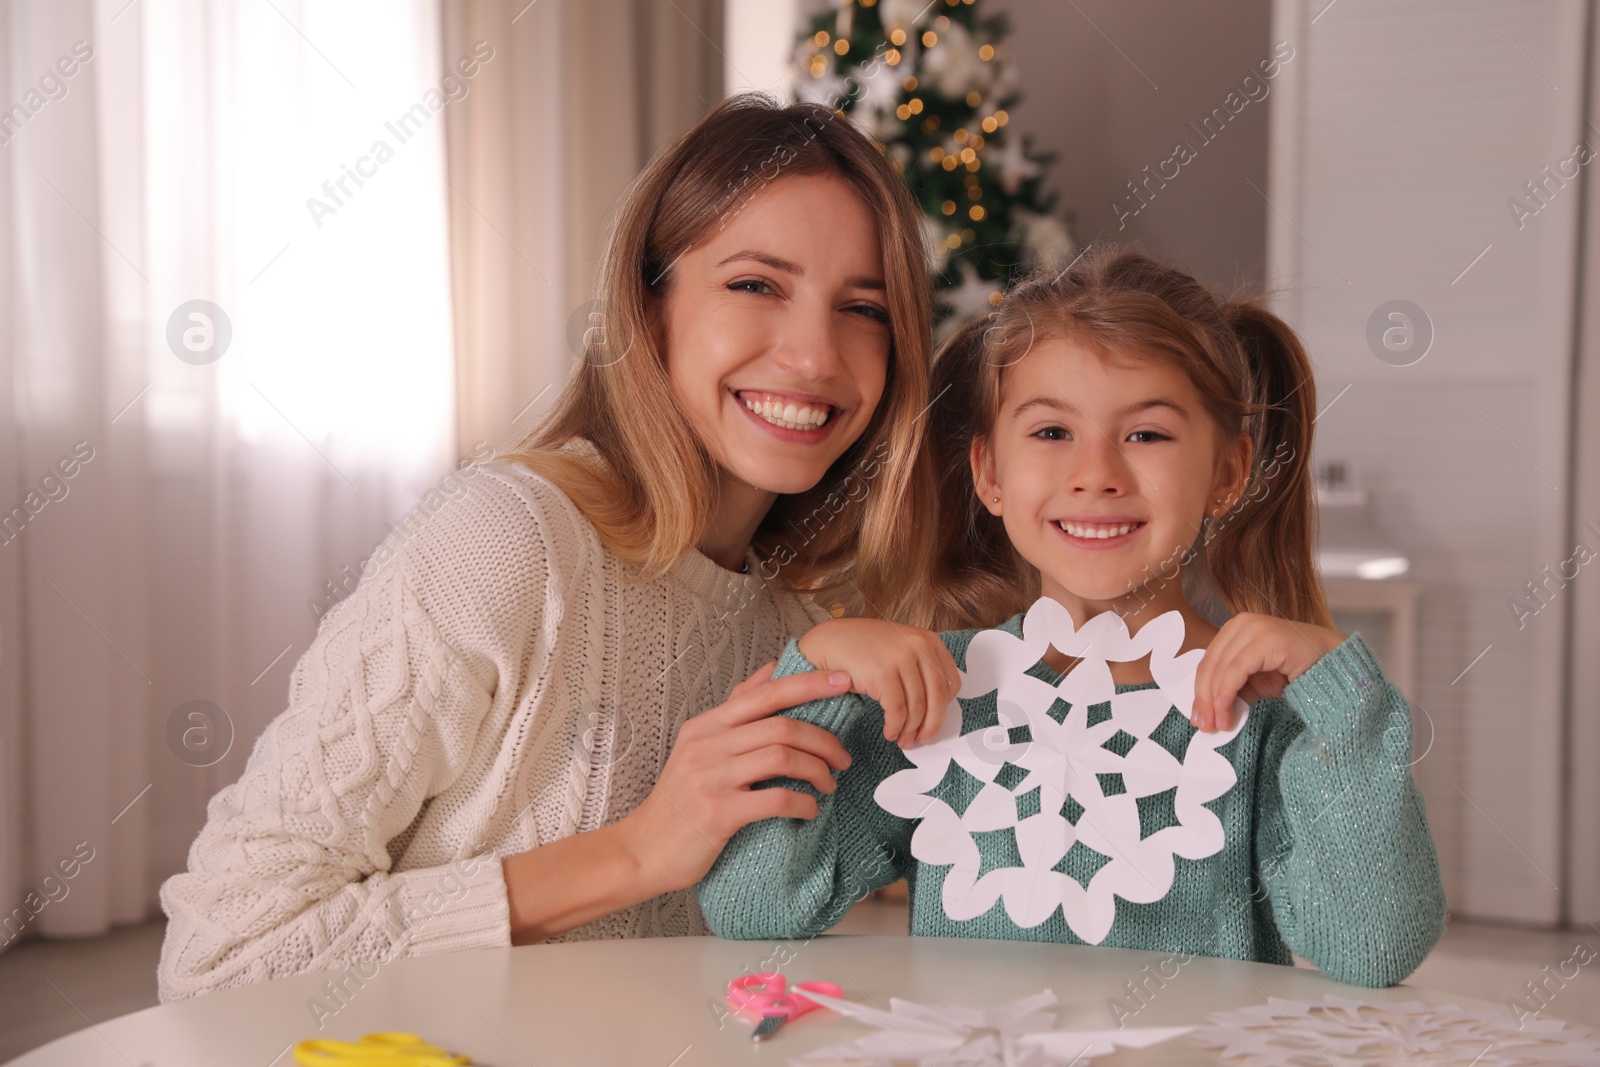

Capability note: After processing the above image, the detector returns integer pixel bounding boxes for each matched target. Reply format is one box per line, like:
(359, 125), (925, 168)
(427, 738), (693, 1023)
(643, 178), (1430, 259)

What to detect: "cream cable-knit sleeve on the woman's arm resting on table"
(158, 472), (576, 1001)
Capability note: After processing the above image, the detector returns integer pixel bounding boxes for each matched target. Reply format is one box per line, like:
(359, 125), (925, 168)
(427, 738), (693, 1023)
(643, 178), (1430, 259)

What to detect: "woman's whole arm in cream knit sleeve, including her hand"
(158, 469), (848, 1000)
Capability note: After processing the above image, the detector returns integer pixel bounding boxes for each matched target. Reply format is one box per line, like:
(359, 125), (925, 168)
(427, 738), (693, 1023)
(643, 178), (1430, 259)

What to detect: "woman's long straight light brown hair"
(499, 93), (933, 622)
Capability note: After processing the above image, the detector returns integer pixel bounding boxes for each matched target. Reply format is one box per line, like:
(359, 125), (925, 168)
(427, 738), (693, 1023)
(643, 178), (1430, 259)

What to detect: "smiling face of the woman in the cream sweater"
(654, 174), (890, 493)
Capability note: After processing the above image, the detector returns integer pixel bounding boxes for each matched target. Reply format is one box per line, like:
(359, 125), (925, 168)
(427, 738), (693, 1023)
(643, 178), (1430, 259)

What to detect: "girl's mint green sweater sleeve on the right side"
(1256, 633), (1445, 987)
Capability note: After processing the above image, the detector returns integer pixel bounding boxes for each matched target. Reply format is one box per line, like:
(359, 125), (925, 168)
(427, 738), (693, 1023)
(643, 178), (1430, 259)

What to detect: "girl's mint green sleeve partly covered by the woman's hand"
(698, 640), (914, 939)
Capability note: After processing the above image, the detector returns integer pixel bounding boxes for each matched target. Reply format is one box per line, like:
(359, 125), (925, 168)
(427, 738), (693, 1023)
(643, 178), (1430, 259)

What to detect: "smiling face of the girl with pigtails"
(973, 341), (1250, 625)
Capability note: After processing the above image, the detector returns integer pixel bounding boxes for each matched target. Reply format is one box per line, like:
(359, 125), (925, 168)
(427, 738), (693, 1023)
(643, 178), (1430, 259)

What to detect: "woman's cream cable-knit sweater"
(160, 461), (827, 1000)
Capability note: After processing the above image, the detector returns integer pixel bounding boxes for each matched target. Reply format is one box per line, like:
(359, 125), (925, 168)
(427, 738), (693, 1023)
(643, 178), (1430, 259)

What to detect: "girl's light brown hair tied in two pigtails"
(925, 245), (1331, 629)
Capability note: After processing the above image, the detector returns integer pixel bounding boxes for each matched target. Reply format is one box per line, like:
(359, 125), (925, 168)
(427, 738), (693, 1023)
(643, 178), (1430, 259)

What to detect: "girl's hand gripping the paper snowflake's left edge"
(800, 619), (962, 749)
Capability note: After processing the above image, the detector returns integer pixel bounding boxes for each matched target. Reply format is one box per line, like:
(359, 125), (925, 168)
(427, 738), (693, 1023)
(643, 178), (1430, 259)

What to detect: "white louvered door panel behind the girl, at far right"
(1269, 0), (1594, 921)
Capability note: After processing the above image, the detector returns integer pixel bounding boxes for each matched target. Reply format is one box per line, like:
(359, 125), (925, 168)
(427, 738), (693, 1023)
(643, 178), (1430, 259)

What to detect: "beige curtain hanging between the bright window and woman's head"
(443, 0), (726, 450)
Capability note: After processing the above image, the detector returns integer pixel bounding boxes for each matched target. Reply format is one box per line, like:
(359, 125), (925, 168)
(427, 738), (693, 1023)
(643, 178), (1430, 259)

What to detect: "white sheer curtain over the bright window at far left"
(0, 0), (464, 945)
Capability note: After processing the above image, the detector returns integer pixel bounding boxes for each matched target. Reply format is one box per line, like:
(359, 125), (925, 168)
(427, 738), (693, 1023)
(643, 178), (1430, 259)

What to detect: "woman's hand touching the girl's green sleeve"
(619, 662), (850, 899)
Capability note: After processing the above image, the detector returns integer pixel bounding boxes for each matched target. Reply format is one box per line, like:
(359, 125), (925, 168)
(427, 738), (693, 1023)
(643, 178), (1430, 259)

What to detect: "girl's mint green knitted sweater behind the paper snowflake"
(698, 614), (1445, 987)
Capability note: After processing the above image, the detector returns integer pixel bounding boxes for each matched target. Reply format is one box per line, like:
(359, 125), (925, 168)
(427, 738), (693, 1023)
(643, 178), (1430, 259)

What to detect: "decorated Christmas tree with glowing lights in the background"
(794, 0), (1074, 336)
